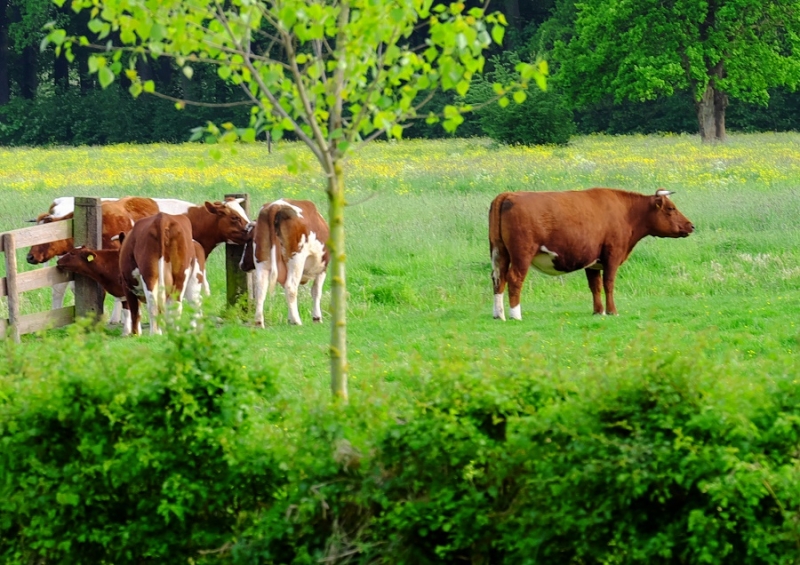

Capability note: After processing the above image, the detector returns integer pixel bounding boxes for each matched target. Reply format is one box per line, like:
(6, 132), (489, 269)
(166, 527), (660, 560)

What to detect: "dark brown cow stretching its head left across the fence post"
(57, 241), (211, 335)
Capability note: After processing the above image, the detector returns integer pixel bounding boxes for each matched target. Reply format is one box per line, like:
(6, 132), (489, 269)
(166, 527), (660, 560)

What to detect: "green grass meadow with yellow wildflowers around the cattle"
(0, 134), (800, 398)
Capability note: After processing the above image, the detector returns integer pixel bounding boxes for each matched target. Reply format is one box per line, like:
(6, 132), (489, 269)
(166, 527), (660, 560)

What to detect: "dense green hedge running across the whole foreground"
(0, 324), (800, 564)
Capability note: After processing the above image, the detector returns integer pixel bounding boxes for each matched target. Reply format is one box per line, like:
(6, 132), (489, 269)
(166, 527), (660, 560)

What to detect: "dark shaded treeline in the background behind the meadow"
(0, 0), (800, 145)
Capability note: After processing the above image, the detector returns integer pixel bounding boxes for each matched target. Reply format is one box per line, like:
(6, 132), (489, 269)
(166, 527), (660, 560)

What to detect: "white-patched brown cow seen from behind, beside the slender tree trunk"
(239, 200), (330, 327)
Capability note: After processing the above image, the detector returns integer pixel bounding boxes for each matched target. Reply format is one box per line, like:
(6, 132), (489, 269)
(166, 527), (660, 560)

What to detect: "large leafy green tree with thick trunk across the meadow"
(554, 0), (800, 141)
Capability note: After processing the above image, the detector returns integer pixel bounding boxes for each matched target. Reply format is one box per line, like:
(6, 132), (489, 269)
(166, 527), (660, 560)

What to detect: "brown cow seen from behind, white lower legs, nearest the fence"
(119, 212), (208, 334)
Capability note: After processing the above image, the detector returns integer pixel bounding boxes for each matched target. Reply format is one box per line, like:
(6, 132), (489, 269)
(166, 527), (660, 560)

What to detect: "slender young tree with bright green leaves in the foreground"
(50, 0), (546, 400)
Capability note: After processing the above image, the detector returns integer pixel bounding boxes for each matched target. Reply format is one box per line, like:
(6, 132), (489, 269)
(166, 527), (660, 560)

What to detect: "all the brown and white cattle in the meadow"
(21, 188), (694, 335)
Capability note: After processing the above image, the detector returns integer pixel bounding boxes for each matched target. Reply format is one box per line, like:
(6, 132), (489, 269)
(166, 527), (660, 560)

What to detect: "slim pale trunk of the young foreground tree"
(328, 161), (347, 402)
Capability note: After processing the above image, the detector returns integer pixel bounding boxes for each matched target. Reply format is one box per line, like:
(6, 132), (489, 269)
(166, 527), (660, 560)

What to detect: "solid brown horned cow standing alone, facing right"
(489, 188), (694, 320)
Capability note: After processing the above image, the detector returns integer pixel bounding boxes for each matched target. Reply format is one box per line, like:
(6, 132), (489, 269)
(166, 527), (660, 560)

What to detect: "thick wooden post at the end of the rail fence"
(72, 197), (105, 320)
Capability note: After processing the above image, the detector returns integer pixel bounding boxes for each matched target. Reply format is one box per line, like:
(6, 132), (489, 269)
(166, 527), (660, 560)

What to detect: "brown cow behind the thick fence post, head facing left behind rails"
(27, 196), (158, 265)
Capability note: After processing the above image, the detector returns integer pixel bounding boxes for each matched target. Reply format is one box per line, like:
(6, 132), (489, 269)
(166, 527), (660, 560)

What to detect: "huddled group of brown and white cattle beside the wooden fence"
(27, 197), (328, 335)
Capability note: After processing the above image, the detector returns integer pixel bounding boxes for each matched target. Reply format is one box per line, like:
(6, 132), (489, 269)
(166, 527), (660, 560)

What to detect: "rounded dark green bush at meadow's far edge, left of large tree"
(467, 55), (575, 145)
